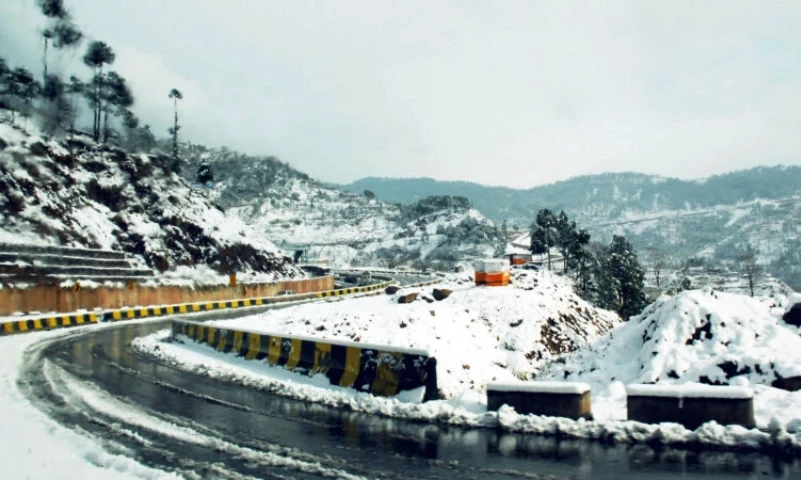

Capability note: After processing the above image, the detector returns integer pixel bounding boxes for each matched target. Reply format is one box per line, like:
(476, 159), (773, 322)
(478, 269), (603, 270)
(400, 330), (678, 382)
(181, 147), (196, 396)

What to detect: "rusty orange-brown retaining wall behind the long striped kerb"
(0, 275), (334, 315)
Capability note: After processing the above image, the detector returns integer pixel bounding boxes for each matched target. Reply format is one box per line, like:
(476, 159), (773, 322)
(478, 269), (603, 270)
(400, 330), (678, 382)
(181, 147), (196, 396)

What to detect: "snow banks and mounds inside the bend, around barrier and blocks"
(134, 272), (801, 451)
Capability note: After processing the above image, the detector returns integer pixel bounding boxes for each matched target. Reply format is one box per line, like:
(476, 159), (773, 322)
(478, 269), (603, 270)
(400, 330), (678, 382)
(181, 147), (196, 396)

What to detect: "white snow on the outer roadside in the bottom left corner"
(0, 325), (179, 480)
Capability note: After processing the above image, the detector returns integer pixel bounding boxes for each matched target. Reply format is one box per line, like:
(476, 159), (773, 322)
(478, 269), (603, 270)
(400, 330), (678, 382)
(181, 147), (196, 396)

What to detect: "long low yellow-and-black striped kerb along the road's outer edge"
(0, 282), (389, 336)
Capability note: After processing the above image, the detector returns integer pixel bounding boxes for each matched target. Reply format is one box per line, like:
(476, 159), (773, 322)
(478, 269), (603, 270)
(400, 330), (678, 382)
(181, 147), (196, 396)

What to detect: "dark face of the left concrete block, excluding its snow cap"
(487, 388), (592, 419)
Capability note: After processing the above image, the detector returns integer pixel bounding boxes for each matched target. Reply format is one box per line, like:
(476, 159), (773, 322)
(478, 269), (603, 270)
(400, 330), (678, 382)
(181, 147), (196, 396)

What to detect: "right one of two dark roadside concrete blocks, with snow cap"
(626, 384), (756, 430)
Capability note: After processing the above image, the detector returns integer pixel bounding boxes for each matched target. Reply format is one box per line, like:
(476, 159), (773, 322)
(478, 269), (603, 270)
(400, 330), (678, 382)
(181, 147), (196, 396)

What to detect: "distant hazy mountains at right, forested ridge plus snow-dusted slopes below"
(343, 170), (801, 289)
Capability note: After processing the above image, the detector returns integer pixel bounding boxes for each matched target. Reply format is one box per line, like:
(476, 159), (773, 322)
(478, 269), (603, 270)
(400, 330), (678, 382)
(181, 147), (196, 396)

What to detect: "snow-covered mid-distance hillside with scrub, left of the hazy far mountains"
(183, 144), (505, 268)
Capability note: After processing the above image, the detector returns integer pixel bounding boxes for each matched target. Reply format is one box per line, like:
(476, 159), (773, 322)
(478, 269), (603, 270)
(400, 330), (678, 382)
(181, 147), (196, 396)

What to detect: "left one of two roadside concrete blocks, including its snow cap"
(487, 382), (592, 419)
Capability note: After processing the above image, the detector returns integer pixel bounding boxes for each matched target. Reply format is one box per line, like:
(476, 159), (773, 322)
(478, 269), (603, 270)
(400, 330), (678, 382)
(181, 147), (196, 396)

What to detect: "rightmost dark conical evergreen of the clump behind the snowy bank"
(596, 235), (646, 319)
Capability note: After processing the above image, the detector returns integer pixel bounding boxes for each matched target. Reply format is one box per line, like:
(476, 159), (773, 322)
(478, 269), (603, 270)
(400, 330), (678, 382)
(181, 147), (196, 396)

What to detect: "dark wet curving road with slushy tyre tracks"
(20, 321), (801, 479)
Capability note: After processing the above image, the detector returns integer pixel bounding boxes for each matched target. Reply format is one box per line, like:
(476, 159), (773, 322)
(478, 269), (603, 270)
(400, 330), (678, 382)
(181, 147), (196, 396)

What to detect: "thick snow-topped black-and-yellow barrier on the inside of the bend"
(172, 320), (439, 401)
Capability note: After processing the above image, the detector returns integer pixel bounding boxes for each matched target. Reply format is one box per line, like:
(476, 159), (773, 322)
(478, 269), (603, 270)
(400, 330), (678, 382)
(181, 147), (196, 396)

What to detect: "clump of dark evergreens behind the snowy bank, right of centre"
(529, 208), (647, 319)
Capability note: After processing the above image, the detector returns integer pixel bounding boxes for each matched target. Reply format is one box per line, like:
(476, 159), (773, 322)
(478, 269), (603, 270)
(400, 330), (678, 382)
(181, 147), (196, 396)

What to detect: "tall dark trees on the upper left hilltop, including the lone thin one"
(0, 0), (183, 172)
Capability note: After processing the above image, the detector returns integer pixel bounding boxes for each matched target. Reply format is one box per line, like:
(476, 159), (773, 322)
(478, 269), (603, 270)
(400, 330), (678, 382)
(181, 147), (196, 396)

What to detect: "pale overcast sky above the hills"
(0, 0), (801, 187)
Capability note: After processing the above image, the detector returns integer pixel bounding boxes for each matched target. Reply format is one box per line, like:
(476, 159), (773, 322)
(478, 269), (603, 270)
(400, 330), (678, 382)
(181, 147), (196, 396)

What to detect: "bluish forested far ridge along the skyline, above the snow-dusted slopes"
(341, 166), (801, 222)
